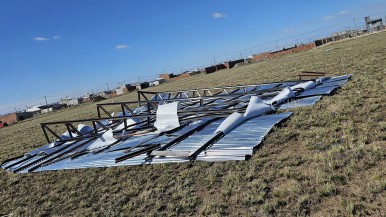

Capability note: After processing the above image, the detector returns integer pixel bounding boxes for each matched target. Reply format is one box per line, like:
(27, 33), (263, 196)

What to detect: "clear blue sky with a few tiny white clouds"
(0, 0), (386, 113)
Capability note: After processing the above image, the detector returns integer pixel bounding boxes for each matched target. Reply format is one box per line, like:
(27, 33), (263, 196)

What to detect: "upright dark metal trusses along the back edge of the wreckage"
(41, 80), (330, 142)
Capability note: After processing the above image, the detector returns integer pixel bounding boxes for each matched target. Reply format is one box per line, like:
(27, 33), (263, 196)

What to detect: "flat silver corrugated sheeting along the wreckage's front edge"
(32, 112), (292, 172)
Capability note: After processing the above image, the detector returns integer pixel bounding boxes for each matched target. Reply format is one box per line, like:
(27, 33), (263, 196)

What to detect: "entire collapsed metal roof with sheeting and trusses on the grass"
(1, 75), (351, 173)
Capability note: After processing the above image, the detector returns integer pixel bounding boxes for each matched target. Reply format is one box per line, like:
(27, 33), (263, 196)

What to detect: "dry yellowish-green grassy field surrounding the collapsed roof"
(0, 32), (386, 216)
